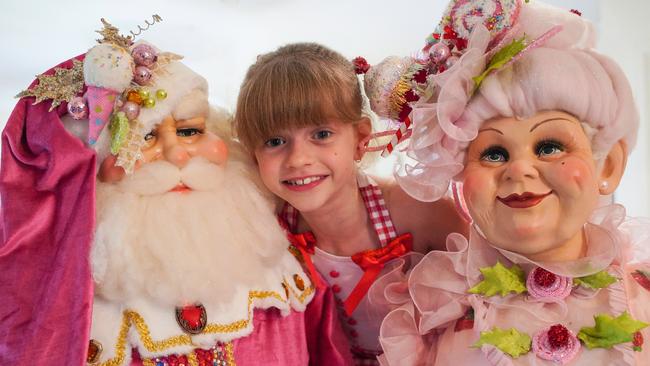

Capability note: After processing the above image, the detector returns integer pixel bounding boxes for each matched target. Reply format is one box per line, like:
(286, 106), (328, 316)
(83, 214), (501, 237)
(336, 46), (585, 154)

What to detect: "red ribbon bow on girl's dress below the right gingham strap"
(343, 233), (413, 316)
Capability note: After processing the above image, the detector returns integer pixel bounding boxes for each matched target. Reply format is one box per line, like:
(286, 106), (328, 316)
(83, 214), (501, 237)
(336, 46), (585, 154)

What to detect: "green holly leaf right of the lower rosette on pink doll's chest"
(578, 311), (648, 349)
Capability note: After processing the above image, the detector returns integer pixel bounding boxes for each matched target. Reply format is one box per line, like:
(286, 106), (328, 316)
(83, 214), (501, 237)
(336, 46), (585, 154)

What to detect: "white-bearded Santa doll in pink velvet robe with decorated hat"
(0, 18), (351, 366)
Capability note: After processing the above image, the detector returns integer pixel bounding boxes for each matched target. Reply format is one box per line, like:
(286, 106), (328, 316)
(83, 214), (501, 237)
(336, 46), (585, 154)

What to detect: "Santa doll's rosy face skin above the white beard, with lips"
(98, 115), (228, 186)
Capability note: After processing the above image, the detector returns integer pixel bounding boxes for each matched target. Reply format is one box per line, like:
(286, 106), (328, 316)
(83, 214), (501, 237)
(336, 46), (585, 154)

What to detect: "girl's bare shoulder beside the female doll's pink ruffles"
(373, 178), (469, 253)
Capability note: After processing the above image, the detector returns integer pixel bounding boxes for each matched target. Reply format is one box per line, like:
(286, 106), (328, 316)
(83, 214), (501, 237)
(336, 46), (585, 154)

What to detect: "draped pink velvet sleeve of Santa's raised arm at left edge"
(0, 55), (95, 366)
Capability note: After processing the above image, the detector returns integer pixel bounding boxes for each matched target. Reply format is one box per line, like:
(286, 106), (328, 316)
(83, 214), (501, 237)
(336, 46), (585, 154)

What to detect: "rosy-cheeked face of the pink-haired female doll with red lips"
(463, 111), (599, 260)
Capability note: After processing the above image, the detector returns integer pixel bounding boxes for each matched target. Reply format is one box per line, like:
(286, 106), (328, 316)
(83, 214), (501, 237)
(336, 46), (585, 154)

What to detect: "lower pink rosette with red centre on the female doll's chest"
(532, 324), (582, 365)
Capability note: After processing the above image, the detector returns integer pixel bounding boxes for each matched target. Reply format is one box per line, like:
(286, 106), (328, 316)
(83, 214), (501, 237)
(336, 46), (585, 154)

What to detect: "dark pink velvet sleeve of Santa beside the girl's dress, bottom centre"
(305, 281), (354, 366)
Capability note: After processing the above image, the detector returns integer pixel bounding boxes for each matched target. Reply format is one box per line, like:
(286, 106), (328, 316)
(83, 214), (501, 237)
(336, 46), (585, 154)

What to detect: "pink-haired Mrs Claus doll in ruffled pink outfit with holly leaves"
(381, 0), (650, 366)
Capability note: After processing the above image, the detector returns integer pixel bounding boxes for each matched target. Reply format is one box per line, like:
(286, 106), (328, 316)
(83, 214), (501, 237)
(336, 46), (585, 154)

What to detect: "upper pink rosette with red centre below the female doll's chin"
(526, 267), (573, 302)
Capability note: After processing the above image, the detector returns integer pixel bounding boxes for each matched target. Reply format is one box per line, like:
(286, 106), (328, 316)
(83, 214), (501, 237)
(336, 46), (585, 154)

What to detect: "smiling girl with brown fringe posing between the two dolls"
(235, 43), (466, 364)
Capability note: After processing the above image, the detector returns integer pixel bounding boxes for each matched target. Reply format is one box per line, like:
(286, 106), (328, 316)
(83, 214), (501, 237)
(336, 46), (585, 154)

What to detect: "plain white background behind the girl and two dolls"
(0, 0), (650, 216)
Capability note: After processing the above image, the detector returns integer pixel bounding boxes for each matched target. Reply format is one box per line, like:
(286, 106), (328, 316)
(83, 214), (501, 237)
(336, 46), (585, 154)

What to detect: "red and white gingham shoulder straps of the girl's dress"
(280, 184), (397, 247)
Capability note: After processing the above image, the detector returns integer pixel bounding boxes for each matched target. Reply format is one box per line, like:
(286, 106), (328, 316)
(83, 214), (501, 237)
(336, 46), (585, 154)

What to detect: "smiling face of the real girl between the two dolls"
(255, 119), (370, 212)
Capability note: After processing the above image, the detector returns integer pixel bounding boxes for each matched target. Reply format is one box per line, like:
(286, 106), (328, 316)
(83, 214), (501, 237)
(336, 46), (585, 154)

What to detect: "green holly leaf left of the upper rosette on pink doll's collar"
(468, 262), (526, 296)
